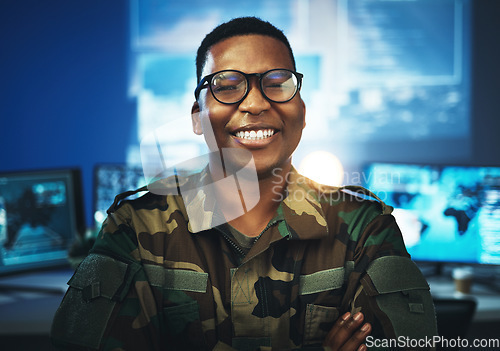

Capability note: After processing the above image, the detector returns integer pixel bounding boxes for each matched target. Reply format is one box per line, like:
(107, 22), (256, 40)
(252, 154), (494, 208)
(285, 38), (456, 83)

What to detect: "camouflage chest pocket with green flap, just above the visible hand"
(299, 262), (354, 345)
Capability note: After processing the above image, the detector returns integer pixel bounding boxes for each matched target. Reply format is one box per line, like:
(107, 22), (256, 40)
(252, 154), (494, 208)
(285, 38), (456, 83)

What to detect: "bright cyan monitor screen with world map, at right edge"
(364, 163), (500, 264)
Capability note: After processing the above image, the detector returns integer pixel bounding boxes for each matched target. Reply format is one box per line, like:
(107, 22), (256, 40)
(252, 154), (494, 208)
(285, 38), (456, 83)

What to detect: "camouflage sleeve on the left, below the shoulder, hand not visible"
(51, 210), (167, 350)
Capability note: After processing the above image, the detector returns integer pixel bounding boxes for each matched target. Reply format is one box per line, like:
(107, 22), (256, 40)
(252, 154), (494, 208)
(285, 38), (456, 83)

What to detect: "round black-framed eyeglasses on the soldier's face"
(194, 68), (304, 105)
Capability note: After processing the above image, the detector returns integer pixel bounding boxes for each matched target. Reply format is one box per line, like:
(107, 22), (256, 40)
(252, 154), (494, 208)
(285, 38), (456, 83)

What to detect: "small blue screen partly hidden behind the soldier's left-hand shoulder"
(94, 164), (146, 230)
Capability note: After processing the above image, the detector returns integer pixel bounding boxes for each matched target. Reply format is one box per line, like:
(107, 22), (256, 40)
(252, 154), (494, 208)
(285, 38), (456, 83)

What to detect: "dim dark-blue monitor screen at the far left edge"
(0, 169), (84, 275)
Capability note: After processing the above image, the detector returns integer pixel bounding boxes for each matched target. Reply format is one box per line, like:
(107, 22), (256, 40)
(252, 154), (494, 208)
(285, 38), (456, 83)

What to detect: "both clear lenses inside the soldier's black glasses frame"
(211, 70), (298, 103)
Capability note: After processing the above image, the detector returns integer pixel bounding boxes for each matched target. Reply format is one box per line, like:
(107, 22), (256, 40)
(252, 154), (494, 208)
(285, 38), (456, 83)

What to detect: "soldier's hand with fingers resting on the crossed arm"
(323, 312), (372, 351)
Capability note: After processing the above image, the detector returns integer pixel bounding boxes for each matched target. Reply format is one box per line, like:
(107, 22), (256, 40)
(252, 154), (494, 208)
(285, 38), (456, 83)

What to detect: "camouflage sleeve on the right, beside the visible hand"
(351, 214), (437, 340)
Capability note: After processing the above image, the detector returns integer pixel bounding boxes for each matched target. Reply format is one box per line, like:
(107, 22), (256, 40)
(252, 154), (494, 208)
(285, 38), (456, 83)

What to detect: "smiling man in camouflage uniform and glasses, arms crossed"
(52, 18), (435, 350)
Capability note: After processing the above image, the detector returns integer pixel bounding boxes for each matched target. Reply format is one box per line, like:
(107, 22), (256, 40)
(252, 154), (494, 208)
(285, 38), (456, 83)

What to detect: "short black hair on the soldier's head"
(196, 17), (295, 83)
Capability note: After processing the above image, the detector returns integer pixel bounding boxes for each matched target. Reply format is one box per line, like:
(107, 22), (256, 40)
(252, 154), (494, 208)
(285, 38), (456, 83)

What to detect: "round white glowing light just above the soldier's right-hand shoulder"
(298, 150), (344, 186)
